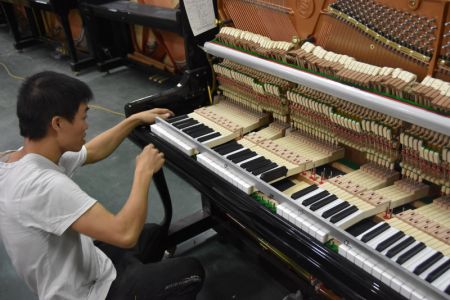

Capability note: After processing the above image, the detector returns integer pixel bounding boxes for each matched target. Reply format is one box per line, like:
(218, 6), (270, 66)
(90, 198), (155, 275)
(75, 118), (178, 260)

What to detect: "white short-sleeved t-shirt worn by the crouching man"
(0, 147), (116, 300)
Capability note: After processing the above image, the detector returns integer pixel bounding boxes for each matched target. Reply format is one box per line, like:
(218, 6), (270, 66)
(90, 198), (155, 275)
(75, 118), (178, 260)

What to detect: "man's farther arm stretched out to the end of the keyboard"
(85, 108), (173, 164)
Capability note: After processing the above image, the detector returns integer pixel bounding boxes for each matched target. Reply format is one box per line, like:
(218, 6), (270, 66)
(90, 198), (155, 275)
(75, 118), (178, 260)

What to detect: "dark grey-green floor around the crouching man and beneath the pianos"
(0, 25), (292, 300)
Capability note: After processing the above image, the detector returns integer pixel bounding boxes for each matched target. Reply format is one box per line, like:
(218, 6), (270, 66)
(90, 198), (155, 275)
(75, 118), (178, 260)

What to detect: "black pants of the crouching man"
(95, 224), (205, 300)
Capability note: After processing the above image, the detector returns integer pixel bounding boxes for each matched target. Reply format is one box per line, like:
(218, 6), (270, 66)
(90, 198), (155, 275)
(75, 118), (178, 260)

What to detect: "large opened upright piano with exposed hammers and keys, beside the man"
(125, 0), (450, 299)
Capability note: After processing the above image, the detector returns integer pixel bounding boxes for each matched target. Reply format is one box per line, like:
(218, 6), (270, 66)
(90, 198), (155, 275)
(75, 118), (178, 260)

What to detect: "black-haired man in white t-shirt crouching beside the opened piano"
(0, 71), (204, 299)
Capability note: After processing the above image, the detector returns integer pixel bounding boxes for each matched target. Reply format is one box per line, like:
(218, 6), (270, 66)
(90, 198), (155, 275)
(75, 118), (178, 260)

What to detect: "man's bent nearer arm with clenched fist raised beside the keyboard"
(71, 145), (164, 248)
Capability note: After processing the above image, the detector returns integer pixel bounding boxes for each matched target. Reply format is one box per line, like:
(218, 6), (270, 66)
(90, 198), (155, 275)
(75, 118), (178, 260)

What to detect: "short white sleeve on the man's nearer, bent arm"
(19, 171), (96, 235)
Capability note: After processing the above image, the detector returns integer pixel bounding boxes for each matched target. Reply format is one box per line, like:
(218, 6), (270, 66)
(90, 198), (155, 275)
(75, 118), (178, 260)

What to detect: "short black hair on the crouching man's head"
(17, 71), (93, 140)
